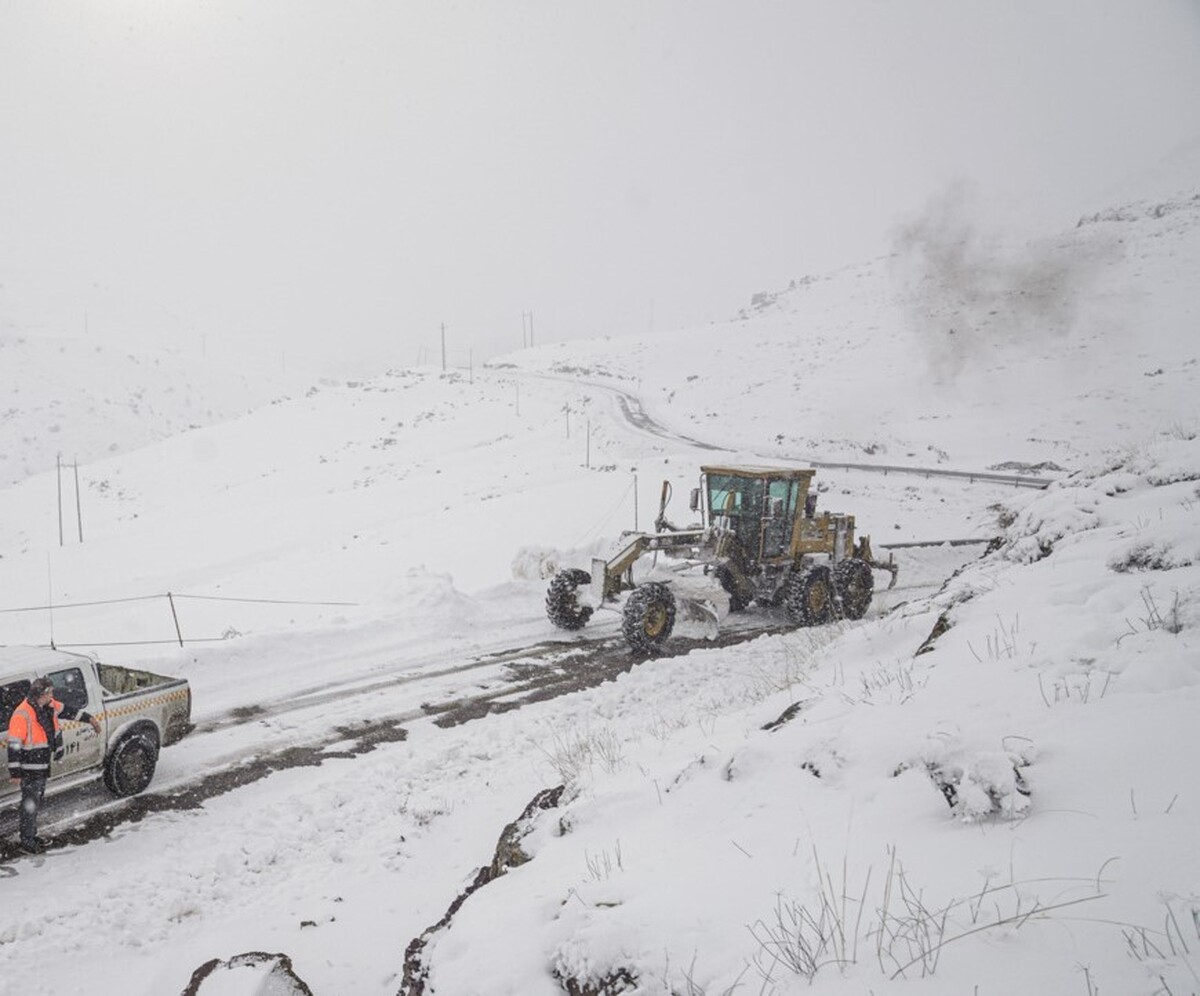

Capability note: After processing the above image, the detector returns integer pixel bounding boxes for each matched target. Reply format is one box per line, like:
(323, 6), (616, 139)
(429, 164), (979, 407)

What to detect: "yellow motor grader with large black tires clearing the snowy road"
(546, 467), (896, 653)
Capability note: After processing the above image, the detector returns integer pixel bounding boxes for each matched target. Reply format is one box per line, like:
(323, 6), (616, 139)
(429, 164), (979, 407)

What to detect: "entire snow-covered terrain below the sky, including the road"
(0, 163), (1200, 996)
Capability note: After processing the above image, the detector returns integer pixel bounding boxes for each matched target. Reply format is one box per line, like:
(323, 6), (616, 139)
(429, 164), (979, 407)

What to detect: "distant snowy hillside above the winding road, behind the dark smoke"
(499, 180), (1200, 470)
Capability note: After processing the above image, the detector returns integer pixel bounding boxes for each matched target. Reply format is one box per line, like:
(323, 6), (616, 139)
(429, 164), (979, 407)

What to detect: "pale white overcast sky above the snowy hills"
(0, 0), (1200, 376)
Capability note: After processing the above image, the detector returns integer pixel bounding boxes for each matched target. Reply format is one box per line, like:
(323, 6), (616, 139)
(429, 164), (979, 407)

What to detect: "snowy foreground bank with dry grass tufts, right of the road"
(415, 437), (1200, 996)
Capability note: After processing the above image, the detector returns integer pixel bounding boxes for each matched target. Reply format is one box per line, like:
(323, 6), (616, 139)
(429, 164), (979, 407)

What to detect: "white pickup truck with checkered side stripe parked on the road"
(0, 647), (192, 806)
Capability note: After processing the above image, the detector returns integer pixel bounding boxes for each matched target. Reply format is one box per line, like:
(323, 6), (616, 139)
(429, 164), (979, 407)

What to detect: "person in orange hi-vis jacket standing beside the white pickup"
(8, 678), (100, 854)
